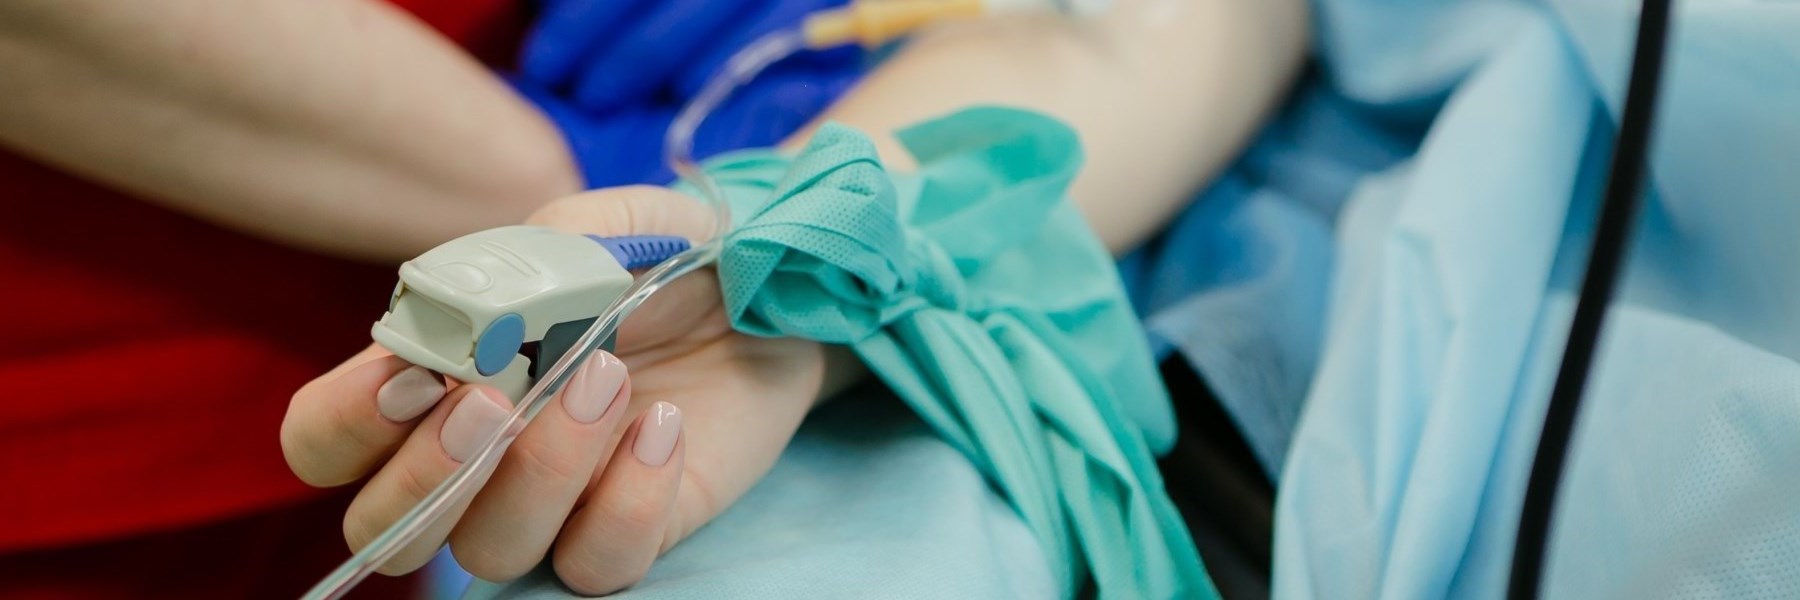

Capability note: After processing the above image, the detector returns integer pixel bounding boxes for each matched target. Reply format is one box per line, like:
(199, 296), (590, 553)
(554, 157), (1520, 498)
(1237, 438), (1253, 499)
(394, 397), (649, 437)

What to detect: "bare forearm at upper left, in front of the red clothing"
(0, 0), (580, 261)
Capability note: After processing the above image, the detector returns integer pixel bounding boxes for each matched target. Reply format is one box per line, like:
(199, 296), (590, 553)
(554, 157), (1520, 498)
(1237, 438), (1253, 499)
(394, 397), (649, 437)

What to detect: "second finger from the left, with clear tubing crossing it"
(344, 386), (513, 575)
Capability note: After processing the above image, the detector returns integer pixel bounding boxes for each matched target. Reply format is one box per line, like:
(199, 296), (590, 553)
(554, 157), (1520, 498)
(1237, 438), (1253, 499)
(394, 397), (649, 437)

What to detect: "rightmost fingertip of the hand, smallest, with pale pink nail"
(553, 396), (686, 595)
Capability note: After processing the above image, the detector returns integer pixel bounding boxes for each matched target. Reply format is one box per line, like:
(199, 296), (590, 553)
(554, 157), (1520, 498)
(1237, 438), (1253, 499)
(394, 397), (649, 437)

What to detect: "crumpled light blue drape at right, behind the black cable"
(1123, 0), (1800, 598)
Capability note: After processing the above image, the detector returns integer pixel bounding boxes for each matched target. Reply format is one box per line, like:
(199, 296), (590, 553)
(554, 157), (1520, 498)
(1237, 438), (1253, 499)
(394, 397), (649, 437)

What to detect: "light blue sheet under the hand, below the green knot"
(464, 391), (1062, 600)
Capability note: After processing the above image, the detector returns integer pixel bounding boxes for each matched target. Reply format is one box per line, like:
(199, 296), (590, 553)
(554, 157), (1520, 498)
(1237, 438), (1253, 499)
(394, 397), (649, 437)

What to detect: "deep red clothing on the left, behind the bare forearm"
(0, 0), (524, 587)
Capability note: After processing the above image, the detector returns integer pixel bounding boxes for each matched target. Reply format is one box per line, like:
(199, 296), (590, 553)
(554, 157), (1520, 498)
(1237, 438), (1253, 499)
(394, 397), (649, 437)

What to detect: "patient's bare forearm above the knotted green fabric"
(802, 0), (1307, 252)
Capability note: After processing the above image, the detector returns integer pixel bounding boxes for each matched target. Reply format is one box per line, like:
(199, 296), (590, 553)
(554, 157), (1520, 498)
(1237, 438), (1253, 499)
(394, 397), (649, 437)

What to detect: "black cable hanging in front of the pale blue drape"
(1507, 0), (1672, 600)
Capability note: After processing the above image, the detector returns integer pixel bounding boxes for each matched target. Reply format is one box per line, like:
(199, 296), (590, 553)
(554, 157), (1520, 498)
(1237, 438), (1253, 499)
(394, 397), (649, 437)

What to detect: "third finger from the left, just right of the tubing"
(450, 351), (630, 582)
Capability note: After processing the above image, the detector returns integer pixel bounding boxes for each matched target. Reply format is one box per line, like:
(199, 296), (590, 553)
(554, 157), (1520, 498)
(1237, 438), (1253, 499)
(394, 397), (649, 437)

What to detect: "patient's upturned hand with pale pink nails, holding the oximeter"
(281, 187), (826, 595)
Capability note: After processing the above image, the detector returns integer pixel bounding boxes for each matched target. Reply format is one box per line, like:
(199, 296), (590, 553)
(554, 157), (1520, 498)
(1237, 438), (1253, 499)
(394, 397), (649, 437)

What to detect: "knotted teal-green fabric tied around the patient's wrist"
(707, 108), (1217, 598)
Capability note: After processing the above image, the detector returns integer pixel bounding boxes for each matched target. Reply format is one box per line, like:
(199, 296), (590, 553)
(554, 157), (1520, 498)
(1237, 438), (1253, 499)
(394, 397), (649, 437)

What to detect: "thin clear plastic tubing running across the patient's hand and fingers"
(304, 31), (805, 600)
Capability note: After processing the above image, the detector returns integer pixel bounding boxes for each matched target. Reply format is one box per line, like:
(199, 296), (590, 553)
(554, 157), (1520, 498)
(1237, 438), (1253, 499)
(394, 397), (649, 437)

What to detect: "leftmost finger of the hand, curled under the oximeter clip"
(281, 346), (445, 486)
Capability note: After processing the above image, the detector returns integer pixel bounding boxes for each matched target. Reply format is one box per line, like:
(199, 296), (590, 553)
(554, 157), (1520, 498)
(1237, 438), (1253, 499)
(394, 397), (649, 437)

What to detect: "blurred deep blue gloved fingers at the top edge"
(520, 0), (859, 112)
